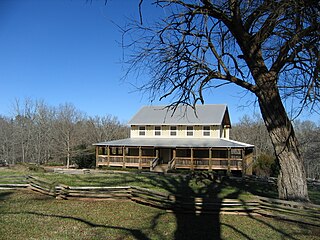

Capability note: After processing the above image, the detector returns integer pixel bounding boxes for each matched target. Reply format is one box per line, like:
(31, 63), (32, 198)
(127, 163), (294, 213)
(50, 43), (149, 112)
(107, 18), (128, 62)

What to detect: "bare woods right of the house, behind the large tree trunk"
(230, 115), (320, 179)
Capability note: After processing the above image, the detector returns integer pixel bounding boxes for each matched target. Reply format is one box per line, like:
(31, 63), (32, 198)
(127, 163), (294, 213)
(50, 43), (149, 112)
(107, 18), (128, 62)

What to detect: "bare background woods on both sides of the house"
(0, 100), (320, 179)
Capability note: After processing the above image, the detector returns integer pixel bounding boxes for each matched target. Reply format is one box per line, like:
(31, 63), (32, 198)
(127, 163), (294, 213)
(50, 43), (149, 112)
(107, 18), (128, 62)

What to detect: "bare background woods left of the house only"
(0, 99), (129, 167)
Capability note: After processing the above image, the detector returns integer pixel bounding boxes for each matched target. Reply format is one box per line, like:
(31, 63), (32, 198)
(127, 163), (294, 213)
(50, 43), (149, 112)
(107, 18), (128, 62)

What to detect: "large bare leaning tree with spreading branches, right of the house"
(124, 0), (320, 201)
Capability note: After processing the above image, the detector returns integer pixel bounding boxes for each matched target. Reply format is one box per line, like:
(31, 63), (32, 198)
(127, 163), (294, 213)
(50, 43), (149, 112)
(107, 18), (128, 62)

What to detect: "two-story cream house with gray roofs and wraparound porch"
(94, 104), (254, 175)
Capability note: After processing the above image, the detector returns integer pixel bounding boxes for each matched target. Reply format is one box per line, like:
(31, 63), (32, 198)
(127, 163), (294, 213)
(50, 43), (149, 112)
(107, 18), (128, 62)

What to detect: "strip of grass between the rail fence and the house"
(0, 165), (320, 205)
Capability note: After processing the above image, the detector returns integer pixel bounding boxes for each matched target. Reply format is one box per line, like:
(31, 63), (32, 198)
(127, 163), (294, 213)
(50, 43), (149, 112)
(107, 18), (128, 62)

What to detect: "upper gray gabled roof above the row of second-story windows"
(129, 104), (231, 125)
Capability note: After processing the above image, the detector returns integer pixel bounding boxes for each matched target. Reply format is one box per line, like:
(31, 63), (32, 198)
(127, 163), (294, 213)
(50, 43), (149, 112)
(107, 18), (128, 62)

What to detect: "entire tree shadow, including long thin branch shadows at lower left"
(8, 173), (318, 240)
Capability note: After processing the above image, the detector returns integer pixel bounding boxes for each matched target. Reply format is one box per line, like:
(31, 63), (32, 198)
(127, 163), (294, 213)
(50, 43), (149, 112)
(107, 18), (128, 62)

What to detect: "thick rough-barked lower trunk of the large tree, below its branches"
(257, 81), (309, 201)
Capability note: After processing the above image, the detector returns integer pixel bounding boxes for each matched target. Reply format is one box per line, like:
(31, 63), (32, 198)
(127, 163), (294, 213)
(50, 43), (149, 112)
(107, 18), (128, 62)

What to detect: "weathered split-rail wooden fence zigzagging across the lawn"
(0, 176), (320, 227)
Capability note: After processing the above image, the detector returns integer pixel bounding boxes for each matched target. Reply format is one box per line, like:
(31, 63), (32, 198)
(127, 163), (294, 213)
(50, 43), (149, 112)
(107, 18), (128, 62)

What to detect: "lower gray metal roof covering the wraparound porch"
(93, 138), (254, 148)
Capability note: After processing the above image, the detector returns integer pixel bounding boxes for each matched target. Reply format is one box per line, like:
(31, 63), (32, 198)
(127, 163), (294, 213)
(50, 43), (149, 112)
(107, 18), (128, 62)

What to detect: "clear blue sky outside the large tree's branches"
(0, 0), (319, 122)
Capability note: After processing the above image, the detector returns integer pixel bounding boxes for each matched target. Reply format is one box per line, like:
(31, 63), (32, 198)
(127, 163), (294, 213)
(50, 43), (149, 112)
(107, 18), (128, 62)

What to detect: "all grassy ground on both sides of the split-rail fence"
(0, 166), (320, 239)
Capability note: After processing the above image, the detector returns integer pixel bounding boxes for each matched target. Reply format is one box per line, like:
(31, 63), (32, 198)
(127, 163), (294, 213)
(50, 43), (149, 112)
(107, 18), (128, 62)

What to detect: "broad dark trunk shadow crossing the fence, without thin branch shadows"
(127, 173), (246, 240)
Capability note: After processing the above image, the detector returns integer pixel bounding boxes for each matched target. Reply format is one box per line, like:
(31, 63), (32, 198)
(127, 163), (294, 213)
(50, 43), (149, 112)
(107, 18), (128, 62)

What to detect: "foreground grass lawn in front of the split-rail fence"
(0, 190), (320, 240)
